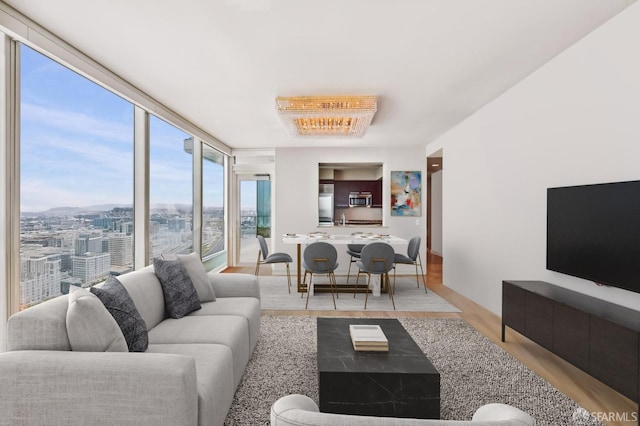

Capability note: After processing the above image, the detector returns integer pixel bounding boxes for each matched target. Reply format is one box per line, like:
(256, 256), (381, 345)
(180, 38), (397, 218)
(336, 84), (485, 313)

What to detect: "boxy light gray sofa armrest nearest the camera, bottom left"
(0, 351), (198, 425)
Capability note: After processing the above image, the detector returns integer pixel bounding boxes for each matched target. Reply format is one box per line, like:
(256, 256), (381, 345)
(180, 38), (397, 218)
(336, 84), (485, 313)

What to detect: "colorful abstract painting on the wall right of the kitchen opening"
(390, 171), (422, 216)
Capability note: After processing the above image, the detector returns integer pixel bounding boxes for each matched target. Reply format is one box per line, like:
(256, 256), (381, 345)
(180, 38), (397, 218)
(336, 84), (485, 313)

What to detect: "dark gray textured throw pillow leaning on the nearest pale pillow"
(91, 275), (149, 352)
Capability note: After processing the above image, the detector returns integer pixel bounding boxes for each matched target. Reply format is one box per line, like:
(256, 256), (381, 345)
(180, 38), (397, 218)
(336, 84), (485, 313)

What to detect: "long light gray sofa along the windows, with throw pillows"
(0, 256), (260, 425)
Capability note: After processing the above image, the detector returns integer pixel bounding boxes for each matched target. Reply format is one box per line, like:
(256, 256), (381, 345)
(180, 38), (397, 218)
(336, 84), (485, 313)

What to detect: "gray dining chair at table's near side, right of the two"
(353, 242), (396, 310)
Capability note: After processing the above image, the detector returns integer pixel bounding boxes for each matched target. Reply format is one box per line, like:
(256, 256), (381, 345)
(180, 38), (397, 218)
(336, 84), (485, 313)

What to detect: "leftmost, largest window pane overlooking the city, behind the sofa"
(19, 45), (134, 309)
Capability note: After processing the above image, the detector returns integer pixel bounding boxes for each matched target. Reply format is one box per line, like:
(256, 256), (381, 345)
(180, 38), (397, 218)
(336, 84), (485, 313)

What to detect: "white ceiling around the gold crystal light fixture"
(6, 0), (635, 148)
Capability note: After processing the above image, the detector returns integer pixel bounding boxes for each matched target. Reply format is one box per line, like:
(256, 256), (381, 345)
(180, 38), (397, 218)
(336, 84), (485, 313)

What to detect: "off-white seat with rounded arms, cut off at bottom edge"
(271, 394), (535, 426)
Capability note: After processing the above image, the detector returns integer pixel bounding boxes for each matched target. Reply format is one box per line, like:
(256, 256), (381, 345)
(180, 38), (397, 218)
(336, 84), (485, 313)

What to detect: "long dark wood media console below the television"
(502, 281), (640, 402)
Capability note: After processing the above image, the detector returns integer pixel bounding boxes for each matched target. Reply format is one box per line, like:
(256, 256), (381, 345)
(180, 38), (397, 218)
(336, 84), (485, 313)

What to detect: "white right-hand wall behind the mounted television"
(427, 3), (640, 314)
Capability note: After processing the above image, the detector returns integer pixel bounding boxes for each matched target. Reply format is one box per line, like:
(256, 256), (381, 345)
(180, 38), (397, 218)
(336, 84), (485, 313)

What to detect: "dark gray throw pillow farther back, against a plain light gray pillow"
(153, 258), (200, 318)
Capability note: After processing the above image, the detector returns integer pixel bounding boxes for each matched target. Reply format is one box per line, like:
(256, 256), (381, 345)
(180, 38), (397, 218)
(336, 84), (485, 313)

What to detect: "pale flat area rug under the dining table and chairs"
(259, 276), (460, 312)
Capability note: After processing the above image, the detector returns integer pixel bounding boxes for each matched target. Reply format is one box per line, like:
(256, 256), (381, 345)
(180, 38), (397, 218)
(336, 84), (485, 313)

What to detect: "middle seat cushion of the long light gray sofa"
(149, 314), (251, 386)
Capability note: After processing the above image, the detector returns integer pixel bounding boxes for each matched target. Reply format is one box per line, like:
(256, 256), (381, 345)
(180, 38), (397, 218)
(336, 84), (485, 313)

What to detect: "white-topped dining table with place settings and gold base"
(282, 232), (409, 295)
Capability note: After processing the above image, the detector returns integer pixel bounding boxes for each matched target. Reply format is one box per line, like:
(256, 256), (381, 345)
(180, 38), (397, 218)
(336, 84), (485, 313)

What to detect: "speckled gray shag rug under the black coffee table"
(225, 316), (601, 426)
